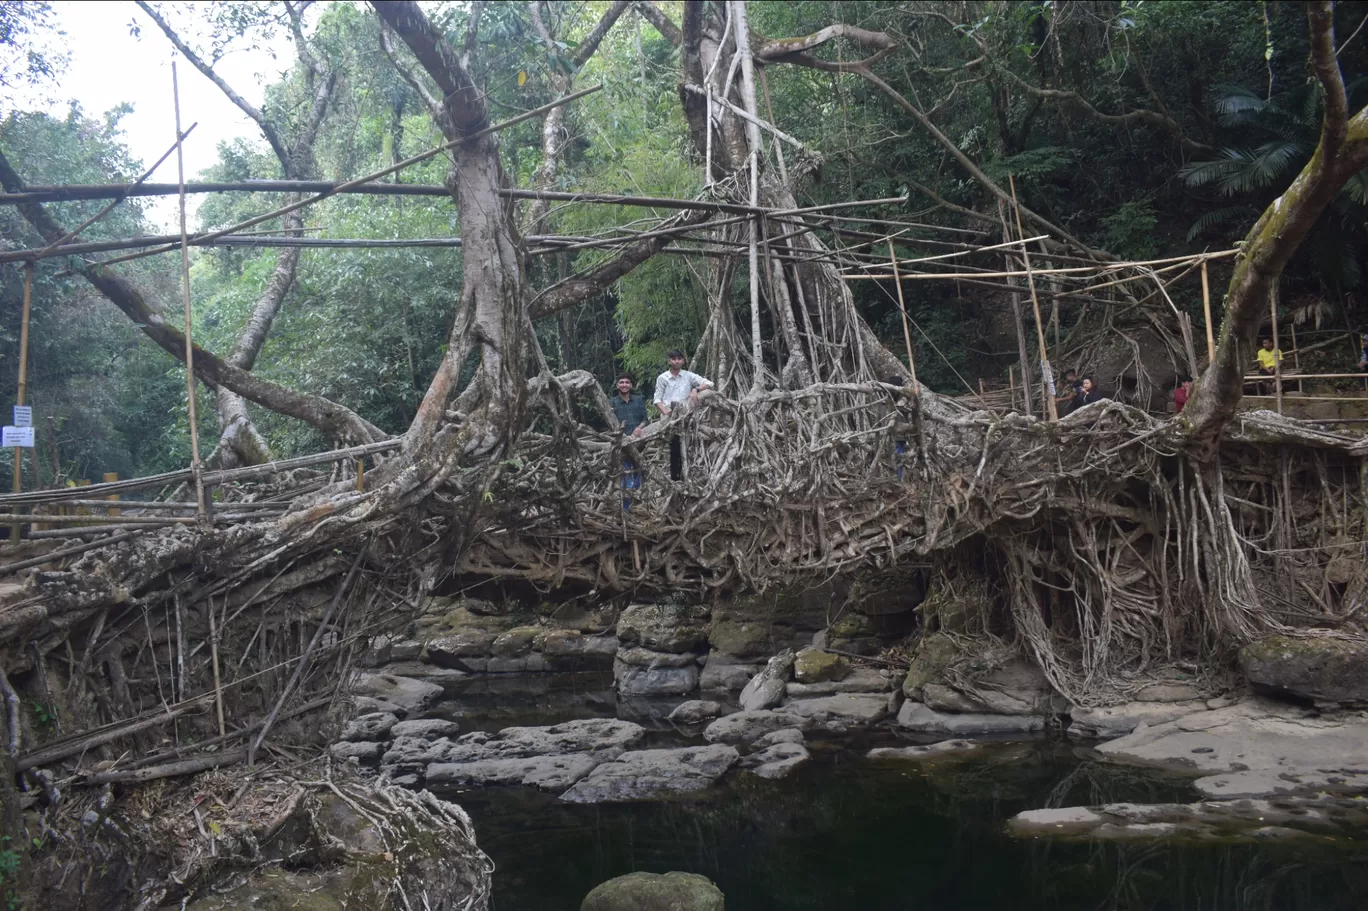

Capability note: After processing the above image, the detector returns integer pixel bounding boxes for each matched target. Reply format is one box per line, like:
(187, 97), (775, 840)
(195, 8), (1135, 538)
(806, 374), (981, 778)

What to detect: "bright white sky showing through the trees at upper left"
(5, 0), (293, 230)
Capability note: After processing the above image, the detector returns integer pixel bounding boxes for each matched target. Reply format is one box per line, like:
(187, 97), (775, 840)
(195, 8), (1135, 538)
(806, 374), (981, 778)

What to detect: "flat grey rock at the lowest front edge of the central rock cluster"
(561, 744), (740, 803)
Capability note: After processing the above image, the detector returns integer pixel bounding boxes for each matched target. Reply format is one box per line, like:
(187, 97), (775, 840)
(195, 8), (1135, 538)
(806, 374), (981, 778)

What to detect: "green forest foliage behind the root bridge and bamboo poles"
(0, 1), (1368, 486)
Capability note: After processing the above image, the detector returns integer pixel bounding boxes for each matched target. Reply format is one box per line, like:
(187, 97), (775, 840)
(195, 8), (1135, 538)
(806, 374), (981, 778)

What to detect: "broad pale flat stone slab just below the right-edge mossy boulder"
(1097, 699), (1368, 796)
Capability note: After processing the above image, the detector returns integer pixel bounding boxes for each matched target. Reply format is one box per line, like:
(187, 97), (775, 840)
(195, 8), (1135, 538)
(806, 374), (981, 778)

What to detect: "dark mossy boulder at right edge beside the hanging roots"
(1239, 636), (1368, 703)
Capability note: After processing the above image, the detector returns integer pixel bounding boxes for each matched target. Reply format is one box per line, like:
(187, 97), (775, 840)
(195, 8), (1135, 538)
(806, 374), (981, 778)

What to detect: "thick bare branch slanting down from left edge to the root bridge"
(0, 152), (387, 443)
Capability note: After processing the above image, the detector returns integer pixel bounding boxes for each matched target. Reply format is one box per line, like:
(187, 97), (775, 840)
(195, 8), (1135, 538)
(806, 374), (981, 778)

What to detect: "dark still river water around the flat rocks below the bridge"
(421, 674), (1368, 911)
